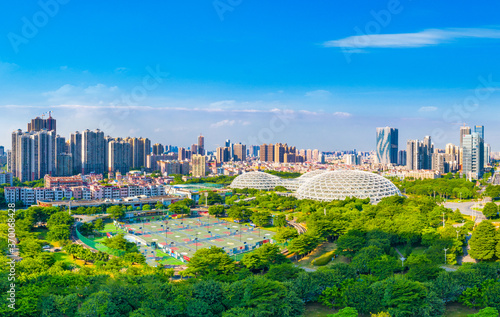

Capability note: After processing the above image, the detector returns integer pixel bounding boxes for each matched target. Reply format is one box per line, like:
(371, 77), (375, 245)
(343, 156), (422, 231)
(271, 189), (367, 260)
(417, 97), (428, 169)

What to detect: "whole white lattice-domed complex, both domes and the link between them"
(230, 170), (401, 203)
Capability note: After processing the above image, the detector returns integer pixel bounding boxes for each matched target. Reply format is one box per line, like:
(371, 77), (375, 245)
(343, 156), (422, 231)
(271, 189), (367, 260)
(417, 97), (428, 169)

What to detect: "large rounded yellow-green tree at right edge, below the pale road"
(469, 221), (496, 261)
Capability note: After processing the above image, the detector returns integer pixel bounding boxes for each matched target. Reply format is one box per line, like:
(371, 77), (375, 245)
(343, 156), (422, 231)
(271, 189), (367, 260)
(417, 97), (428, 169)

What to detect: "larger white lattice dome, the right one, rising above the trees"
(296, 171), (401, 203)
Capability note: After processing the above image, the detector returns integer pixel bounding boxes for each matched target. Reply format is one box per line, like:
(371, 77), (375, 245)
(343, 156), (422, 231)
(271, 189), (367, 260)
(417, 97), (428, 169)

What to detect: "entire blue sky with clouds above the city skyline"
(0, 0), (500, 151)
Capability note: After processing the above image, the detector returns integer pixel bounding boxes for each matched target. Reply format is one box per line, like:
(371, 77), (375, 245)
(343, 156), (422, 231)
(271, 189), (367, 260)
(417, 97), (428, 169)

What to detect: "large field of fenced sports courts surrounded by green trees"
(117, 216), (274, 261)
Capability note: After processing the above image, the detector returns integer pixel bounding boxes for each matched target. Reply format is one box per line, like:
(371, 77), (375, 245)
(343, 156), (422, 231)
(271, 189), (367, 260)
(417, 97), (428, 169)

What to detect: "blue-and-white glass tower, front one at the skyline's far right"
(462, 132), (484, 179)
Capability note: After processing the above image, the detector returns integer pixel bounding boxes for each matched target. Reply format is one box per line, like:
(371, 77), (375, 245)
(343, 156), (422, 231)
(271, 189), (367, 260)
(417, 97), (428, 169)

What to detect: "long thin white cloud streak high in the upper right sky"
(323, 28), (500, 53)
